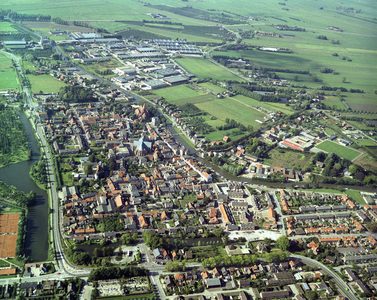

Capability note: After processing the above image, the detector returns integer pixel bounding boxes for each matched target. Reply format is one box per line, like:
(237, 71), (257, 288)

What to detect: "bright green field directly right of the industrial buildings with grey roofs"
(177, 58), (242, 81)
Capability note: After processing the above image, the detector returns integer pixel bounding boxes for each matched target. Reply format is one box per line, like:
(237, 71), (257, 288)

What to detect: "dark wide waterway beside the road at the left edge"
(0, 113), (48, 262)
